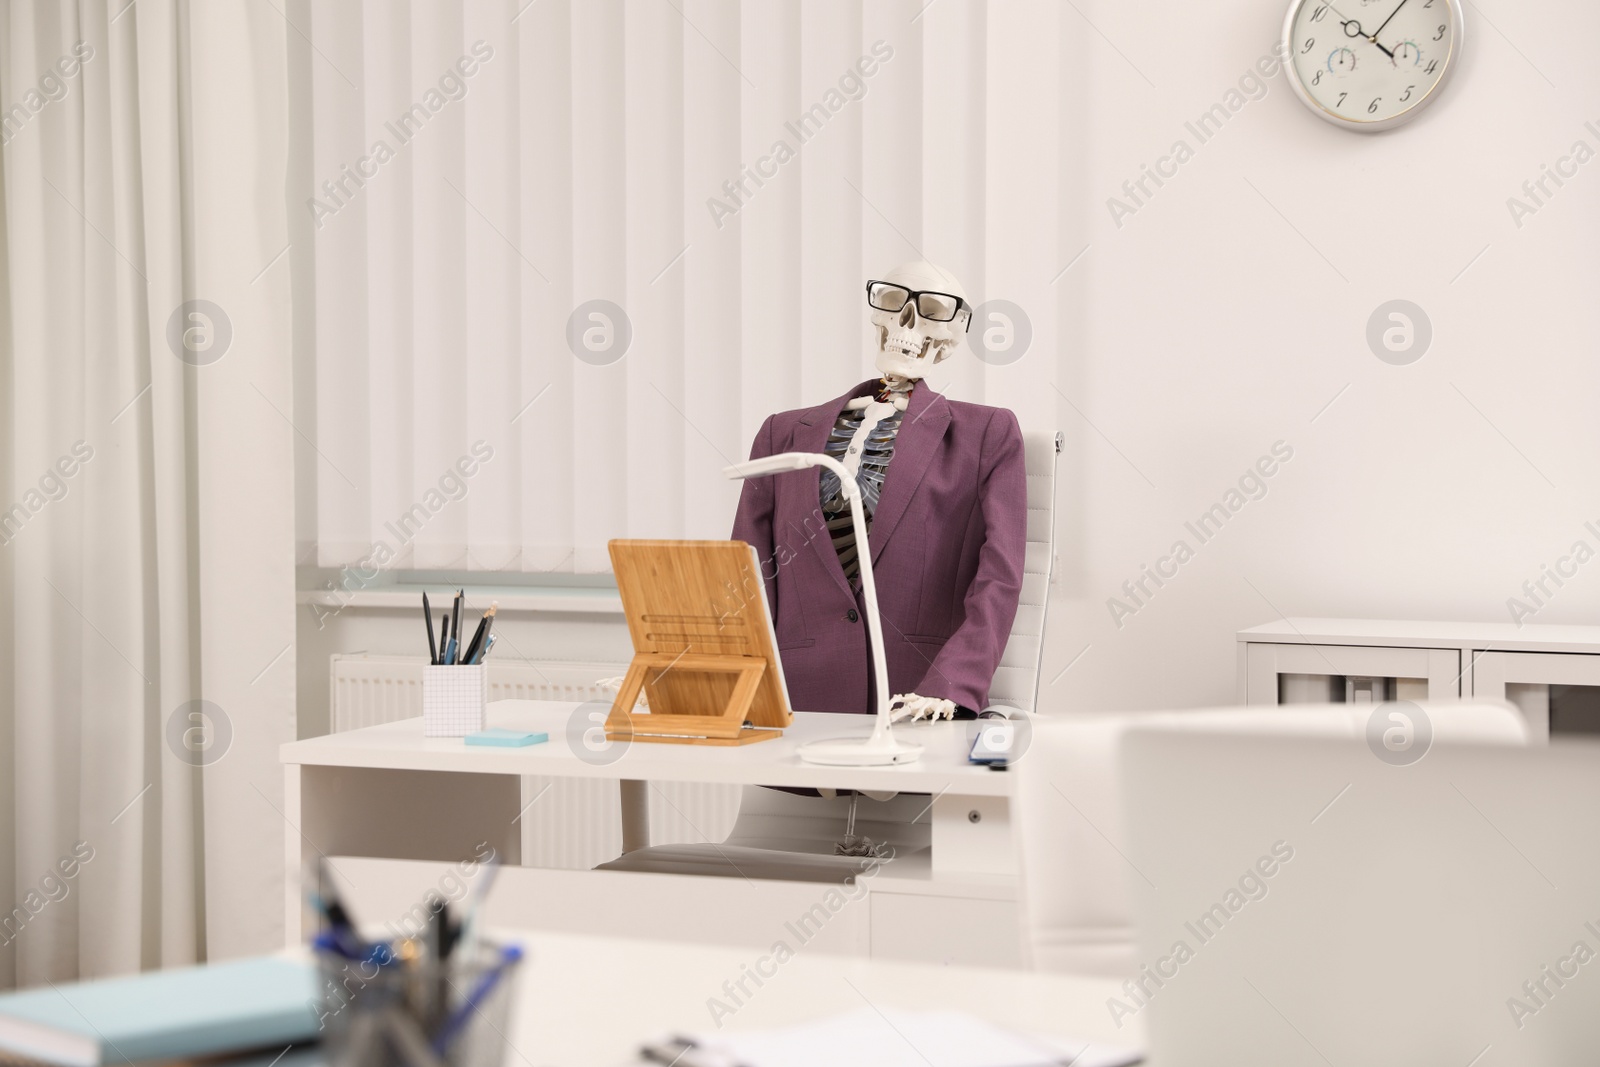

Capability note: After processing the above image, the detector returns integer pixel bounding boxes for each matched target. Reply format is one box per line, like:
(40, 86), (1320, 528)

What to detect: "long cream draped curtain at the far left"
(0, 0), (296, 984)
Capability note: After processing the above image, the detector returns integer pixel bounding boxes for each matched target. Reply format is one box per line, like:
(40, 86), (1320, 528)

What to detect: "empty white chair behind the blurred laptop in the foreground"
(1013, 704), (1530, 977)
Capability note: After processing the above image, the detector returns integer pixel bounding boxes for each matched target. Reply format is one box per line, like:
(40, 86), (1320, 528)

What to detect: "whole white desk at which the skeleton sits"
(282, 701), (1016, 963)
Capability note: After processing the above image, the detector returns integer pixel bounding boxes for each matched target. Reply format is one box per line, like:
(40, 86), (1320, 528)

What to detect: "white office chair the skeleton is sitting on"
(597, 434), (1062, 881)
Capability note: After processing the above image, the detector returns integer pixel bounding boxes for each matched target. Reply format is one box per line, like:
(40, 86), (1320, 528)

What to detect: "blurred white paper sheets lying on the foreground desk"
(675, 1008), (1142, 1067)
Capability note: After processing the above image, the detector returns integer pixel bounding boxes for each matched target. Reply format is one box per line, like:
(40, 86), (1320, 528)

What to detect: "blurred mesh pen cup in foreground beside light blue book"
(317, 942), (522, 1067)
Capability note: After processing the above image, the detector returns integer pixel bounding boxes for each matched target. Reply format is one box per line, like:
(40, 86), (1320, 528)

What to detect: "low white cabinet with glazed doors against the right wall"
(1238, 619), (1600, 741)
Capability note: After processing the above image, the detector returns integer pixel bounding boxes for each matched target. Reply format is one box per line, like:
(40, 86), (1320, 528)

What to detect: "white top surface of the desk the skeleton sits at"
(280, 701), (1011, 797)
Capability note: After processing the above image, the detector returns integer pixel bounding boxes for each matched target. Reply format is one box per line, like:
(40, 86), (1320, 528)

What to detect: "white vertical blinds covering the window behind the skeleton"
(304, 0), (1068, 584)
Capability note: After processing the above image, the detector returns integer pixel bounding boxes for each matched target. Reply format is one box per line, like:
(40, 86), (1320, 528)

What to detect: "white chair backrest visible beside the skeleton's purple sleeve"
(989, 434), (1062, 713)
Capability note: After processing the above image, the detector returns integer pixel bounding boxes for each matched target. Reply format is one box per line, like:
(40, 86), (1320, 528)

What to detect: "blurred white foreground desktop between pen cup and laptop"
(491, 927), (1144, 1067)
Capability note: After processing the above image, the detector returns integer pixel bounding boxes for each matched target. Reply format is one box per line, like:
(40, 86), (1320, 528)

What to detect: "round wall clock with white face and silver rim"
(1283, 0), (1461, 130)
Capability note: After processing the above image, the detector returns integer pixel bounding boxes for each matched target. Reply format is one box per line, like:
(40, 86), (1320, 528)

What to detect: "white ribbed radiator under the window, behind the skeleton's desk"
(328, 653), (741, 870)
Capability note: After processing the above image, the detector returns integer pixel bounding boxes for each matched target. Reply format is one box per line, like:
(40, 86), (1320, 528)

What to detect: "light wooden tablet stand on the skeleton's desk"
(605, 541), (794, 745)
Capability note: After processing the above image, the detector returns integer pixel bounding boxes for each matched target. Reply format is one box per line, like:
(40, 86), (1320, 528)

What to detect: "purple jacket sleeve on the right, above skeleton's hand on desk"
(917, 408), (1027, 712)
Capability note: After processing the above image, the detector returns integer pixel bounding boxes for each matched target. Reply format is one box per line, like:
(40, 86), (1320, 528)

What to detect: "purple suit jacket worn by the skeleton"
(733, 379), (1027, 712)
